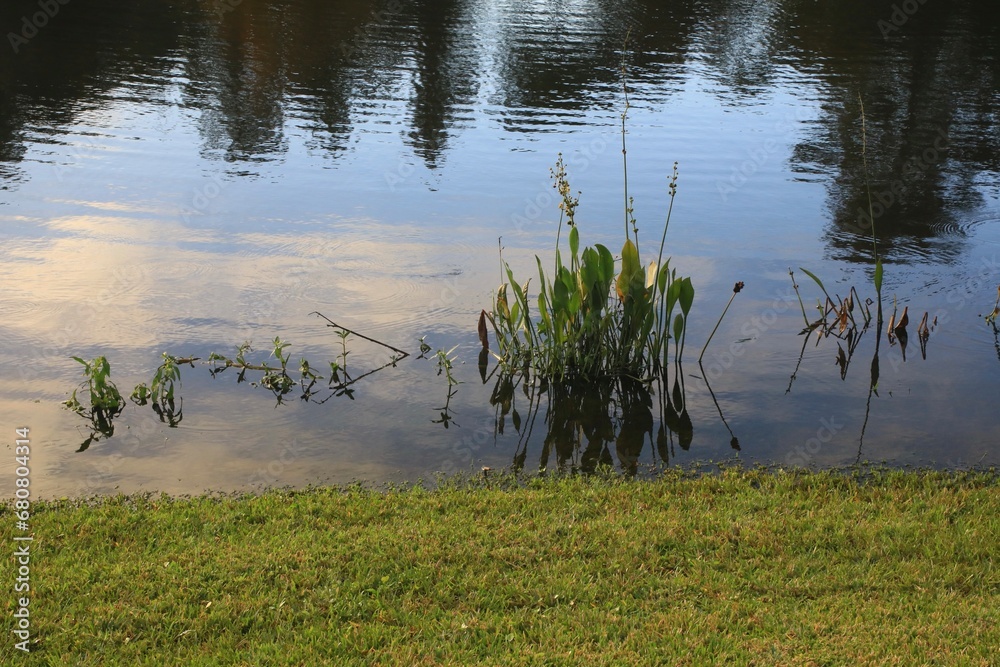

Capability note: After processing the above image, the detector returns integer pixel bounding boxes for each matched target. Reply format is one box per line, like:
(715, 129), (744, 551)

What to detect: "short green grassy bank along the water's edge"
(0, 472), (1000, 667)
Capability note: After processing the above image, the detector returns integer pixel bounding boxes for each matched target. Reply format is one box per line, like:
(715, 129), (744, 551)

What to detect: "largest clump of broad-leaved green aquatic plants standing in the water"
(480, 155), (694, 380)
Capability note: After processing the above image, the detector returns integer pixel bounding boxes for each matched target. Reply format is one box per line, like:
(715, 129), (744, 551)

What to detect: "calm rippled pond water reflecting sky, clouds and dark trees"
(0, 0), (1000, 496)
